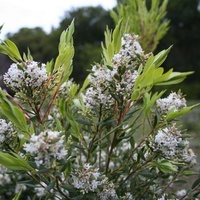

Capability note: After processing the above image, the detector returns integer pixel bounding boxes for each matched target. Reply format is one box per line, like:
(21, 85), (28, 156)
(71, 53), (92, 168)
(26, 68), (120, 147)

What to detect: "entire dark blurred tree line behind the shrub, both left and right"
(1, 0), (200, 99)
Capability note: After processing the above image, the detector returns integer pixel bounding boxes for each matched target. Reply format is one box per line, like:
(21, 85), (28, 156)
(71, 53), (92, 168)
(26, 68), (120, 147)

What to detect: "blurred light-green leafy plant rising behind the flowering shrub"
(111, 0), (169, 52)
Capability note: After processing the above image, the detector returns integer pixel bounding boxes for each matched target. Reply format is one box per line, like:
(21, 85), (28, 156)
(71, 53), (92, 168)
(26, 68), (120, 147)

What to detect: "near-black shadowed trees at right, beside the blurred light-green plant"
(158, 0), (200, 85)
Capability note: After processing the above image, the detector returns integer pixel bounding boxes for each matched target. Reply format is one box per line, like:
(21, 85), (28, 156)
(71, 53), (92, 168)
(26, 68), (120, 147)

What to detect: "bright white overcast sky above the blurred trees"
(0, 0), (116, 39)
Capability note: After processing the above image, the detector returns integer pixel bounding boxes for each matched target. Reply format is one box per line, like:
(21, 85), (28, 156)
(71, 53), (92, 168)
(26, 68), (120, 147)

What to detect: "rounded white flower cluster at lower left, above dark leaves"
(24, 130), (67, 167)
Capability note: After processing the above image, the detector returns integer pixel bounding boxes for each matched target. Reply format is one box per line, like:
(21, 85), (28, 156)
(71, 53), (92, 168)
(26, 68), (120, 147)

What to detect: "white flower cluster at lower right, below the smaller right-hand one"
(154, 124), (196, 165)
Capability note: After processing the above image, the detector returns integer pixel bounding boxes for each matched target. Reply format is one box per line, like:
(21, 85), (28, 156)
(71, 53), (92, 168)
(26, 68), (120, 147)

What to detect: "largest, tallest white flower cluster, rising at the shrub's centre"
(83, 34), (145, 108)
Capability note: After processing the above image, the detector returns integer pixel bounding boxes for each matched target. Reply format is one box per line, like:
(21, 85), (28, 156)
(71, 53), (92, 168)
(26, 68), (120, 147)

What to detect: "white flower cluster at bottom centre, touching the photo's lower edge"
(72, 163), (118, 200)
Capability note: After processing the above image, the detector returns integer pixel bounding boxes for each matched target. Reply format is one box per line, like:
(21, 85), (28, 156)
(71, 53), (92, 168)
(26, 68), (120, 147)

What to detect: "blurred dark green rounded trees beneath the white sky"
(8, 6), (114, 83)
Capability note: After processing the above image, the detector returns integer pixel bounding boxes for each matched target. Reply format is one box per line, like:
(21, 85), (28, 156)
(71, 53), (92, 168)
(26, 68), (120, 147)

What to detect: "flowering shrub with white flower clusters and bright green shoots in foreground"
(0, 20), (200, 200)
